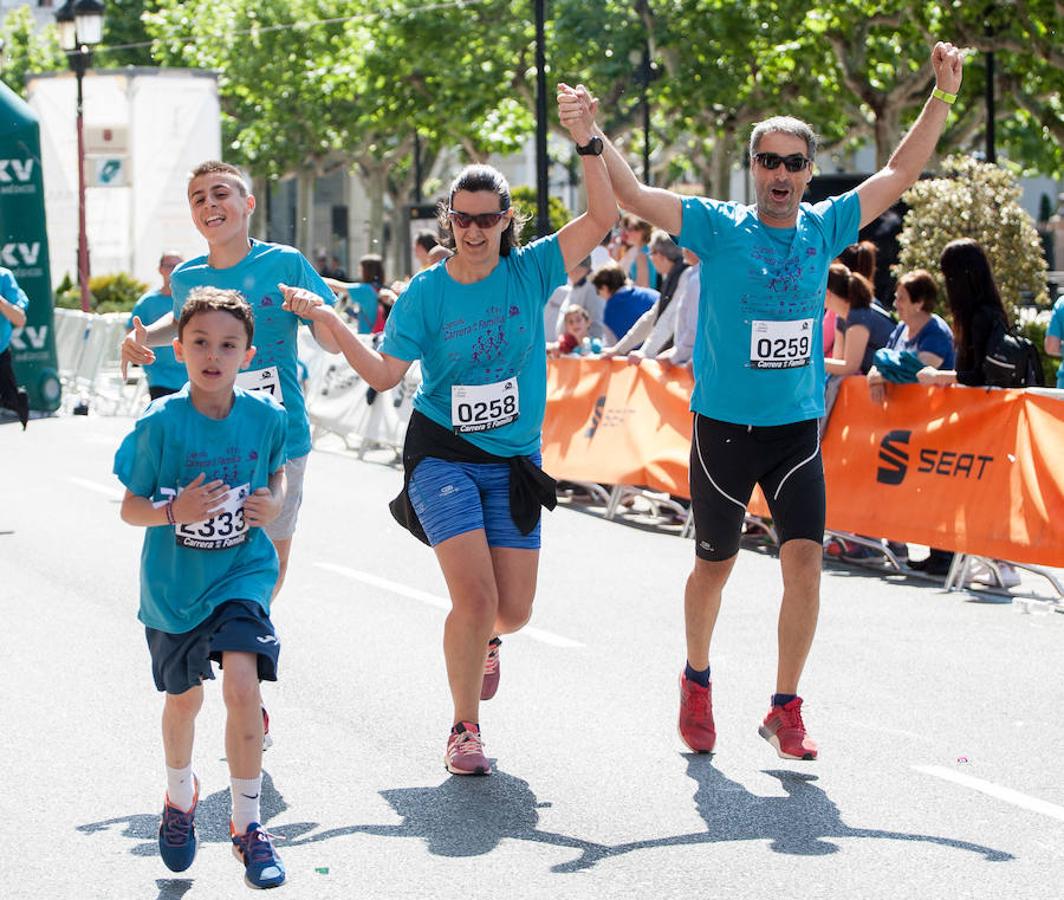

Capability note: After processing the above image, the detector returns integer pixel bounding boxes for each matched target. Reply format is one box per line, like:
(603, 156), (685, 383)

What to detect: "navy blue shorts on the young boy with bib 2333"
(145, 600), (281, 694)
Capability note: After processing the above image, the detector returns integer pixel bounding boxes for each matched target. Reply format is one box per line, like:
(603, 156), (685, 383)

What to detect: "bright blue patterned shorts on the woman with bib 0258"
(406, 453), (541, 550)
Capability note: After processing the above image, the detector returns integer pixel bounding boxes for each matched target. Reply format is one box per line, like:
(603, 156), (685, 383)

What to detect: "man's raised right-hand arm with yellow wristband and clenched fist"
(855, 41), (963, 228)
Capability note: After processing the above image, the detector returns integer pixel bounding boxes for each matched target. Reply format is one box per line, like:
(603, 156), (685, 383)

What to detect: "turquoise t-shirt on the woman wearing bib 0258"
(380, 235), (565, 456)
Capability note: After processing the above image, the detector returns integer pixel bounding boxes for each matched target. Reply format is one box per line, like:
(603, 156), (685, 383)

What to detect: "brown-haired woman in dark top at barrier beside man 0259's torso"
(824, 263), (894, 377)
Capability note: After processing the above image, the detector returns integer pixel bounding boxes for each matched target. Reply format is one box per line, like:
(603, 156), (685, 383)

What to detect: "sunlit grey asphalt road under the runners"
(0, 416), (1064, 900)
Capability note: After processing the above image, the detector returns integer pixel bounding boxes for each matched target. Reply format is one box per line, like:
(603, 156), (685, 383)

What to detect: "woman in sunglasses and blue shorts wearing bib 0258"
(294, 84), (617, 774)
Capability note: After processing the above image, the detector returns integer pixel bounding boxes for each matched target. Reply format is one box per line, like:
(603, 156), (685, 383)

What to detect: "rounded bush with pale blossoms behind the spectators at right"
(894, 156), (1049, 313)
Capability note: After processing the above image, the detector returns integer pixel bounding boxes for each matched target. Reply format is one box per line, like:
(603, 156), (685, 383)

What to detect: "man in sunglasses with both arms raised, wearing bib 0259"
(562, 43), (962, 760)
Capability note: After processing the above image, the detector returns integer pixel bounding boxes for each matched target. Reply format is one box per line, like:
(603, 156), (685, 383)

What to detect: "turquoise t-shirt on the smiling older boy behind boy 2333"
(170, 239), (336, 460)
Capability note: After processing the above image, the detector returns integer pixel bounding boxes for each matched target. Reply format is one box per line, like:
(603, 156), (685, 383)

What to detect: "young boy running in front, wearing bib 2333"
(115, 287), (287, 887)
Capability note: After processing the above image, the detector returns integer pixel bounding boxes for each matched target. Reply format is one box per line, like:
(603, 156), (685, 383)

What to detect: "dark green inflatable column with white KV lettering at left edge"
(0, 81), (60, 412)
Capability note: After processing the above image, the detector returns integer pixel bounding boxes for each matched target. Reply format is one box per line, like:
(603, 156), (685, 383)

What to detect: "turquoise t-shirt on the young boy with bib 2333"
(114, 384), (287, 634)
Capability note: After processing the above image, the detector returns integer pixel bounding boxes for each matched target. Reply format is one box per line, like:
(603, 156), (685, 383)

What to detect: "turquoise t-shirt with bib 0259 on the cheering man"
(678, 190), (861, 426)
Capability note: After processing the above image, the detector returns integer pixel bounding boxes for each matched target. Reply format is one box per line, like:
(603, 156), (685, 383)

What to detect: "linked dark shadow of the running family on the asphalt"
(78, 753), (1015, 880)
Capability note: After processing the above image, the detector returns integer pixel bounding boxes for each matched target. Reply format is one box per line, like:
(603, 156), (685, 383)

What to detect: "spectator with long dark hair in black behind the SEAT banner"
(916, 237), (1009, 387)
